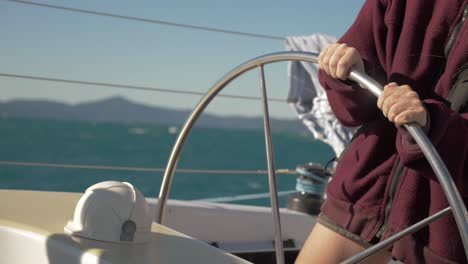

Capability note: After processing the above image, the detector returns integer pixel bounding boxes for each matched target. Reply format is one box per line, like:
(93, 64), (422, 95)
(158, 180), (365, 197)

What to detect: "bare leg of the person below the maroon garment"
(296, 223), (391, 264)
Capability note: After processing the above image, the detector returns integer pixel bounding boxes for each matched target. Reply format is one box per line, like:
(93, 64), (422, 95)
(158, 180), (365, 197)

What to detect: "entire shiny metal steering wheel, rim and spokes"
(155, 52), (468, 263)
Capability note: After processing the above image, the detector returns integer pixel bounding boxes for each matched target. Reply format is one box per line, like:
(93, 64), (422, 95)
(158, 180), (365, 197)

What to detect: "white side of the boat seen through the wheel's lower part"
(147, 199), (316, 253)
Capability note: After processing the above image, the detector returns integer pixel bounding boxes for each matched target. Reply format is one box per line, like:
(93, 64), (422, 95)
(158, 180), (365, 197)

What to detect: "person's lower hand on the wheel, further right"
(377, 83), (429, 128)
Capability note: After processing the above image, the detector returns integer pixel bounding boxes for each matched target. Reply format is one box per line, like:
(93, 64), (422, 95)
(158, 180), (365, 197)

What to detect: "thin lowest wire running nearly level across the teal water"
(0, 161), (297, 175)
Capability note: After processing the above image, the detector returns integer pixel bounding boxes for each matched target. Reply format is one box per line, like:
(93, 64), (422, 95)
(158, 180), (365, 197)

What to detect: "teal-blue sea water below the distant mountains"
(0, 118), (334, 205)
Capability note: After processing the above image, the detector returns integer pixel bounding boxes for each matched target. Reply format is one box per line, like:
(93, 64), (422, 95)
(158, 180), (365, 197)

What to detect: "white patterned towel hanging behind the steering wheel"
(286, 34), (356, 157)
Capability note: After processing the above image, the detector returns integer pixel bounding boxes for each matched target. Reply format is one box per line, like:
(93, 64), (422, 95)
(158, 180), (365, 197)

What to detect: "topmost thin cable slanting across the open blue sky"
(3, 0), (285, 40)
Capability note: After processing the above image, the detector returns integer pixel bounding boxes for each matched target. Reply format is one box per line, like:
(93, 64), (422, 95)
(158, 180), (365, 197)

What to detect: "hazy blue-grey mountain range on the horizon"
(0, 97), (306, 133)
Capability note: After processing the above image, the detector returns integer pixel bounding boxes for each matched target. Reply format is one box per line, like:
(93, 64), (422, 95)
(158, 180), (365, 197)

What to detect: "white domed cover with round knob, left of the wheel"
(65, 181), (151, 243)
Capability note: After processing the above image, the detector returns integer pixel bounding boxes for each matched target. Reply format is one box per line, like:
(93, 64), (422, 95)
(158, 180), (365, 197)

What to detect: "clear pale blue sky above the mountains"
(0, 0), (364, 118)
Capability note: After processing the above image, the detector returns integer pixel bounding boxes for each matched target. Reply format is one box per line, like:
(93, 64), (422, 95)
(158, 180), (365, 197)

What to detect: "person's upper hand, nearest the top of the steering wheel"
(318, 43), (364, 81)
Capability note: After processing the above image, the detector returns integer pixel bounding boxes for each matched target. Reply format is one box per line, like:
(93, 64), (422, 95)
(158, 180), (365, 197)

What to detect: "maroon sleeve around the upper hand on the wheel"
(319, 0), (387, 126)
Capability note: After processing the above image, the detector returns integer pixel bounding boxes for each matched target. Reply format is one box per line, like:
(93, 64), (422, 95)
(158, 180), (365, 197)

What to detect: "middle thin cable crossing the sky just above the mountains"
(0, 73), (286, 103)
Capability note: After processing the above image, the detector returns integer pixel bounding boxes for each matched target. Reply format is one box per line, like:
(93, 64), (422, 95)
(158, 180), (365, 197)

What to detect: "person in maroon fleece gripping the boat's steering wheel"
(296, 0), (468, 263)
